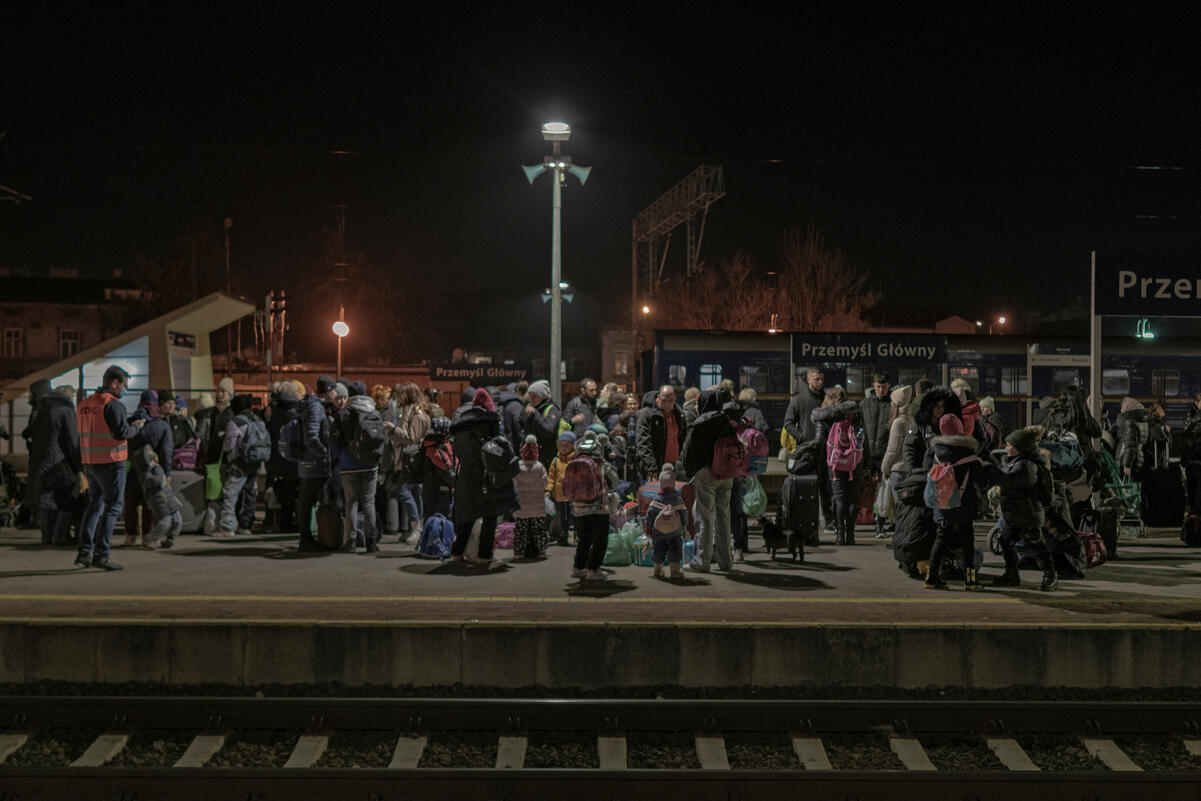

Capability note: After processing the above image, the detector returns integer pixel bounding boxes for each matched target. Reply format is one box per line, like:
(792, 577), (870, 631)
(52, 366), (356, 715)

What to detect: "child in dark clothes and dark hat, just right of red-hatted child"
(987, 425), (1059, 592)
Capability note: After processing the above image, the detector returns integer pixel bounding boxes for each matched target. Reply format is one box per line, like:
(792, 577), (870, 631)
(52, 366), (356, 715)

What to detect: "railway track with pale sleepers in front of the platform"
(0, 697), (1201, 801)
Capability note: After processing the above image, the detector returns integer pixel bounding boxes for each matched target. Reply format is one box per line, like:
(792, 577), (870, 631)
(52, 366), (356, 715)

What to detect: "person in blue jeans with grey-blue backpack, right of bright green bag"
(213, 395), (271, 537)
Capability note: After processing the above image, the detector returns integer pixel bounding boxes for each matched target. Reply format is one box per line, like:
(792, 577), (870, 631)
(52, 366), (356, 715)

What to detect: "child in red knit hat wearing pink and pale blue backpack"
(926, 414), (987, 590)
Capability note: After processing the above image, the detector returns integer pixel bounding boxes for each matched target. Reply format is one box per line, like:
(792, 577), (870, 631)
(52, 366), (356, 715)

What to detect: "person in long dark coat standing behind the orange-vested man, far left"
(26, 381), (83, 545)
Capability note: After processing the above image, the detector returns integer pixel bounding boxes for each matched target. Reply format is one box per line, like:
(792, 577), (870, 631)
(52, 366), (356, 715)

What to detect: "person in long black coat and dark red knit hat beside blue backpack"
(450, 389), (516, 567)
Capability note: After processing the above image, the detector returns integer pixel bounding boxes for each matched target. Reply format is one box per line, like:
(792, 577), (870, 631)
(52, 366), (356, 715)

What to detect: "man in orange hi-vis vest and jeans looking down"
(74, 364), (145, 570)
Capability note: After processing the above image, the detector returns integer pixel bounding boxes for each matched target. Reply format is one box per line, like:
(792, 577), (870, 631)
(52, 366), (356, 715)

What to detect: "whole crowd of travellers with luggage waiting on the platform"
(18, 366), (1201, 590)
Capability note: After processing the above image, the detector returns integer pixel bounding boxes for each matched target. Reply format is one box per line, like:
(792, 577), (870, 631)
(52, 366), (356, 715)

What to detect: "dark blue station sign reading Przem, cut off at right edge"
(1094, 252), (1201, 317)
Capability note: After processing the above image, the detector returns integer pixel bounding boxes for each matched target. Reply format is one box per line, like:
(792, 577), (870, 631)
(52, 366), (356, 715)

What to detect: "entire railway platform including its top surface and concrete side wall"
(0, 527), (1201, 687)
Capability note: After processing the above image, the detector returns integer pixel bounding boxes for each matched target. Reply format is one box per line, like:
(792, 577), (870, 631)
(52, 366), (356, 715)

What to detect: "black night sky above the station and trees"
(0, 2), (1201, 353)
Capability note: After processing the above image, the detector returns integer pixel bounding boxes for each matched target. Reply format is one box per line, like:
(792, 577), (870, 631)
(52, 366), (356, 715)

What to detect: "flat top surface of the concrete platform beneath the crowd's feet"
(0, 526), (1201, 627)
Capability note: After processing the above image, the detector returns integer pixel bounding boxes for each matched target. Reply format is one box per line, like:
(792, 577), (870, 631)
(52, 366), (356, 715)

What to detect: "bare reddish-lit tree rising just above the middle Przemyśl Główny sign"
(777, 225), (877, 331)
